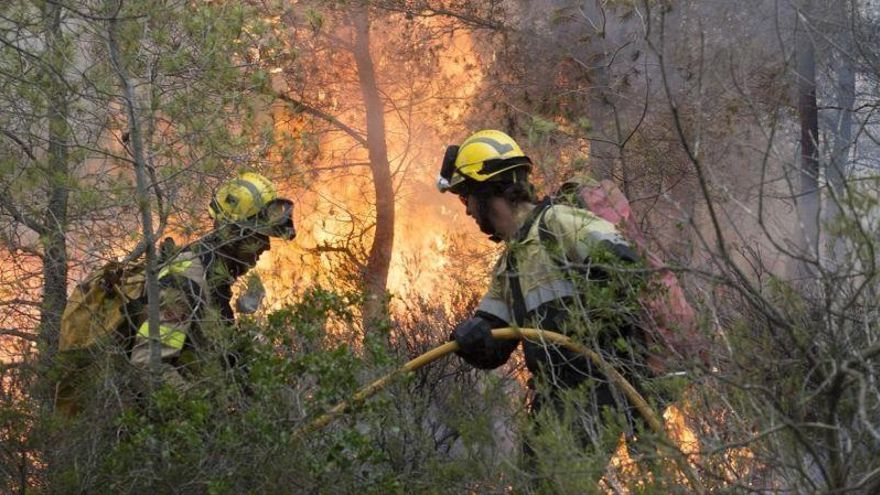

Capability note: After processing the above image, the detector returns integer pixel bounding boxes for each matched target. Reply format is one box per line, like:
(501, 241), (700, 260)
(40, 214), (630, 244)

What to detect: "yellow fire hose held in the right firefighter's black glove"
(294, 327), (705, 493)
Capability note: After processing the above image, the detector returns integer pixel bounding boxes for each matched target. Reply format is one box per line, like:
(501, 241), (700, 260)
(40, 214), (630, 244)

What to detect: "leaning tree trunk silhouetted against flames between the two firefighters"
(352, 7), (394, 330)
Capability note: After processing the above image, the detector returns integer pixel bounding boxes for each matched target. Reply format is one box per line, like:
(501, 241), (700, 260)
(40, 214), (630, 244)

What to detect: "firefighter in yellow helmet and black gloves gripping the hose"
(437, 130), (644, 472)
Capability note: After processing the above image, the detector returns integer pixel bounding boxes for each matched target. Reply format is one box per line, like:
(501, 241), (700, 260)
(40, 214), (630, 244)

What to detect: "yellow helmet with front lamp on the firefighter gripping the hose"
(437, 130), (532, 194)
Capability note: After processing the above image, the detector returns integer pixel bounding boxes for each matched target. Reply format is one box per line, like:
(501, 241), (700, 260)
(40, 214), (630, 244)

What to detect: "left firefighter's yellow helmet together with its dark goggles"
(208, 172), (296, 240)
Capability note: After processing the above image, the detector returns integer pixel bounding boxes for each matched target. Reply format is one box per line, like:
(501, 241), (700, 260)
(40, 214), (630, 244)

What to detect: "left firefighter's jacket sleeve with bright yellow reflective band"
(131, 276), (199, 367)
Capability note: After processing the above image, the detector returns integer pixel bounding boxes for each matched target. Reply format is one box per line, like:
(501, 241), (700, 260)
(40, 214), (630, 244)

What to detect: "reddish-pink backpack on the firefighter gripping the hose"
(541, 178), (708, 374)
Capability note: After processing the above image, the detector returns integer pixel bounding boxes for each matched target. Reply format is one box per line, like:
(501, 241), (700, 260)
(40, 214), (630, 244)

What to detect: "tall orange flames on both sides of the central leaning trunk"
(251, 20), (493, 318)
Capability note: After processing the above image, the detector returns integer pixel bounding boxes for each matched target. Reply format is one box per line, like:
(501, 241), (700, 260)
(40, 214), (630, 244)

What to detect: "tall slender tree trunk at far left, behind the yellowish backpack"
(40, 3), (70, 362)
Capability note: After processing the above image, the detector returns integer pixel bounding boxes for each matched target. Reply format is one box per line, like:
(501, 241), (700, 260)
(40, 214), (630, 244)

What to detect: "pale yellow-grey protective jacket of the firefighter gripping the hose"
(459, 201), (641, 388)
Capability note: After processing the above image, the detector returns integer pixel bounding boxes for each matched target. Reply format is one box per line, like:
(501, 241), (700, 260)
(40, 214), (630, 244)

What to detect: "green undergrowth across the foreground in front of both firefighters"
(3, 280), (716, 493)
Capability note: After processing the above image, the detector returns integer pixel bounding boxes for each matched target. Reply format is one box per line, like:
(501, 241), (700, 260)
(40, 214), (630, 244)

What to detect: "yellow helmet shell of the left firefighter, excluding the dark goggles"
(208, 172), (278, 223)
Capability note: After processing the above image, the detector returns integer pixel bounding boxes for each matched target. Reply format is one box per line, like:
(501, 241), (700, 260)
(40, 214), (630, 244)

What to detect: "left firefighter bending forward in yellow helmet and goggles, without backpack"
(131, 172), (296, 386)
